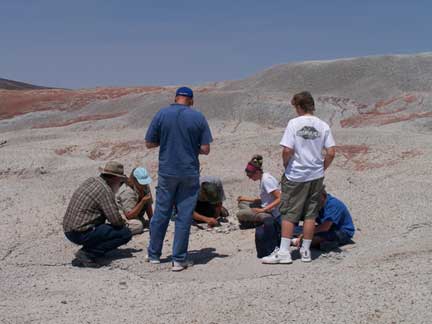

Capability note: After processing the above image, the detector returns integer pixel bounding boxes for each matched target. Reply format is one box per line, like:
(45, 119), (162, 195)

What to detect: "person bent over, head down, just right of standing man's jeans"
(193, 176), (229, 227)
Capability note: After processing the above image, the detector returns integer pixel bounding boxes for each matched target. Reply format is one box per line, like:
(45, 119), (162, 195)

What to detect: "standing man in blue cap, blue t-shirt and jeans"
(145, 87), (213, 271)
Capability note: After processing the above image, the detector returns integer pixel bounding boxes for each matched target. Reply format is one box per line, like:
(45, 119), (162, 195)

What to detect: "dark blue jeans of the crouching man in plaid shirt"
(65, 224), (132, 257)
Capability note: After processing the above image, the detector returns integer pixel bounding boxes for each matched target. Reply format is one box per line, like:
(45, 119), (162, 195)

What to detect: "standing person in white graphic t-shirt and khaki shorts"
(262, 91), (336, 264)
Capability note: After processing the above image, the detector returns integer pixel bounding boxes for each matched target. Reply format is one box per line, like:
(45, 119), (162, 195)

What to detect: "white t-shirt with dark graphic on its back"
(280, 115), (335, 182)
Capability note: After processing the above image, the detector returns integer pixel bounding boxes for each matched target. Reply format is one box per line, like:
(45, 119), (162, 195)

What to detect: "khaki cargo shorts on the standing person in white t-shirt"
(280, 174), (324, 224)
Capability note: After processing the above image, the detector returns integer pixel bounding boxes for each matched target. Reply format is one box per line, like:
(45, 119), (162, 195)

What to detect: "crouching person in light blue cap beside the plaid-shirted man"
(116, 167), (153, 235)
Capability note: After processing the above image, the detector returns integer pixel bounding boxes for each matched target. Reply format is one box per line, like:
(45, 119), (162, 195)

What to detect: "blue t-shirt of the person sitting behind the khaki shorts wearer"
(316, 194), (355, 237)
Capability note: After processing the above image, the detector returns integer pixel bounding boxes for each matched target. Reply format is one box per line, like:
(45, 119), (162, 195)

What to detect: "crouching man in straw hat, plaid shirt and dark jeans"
(63, 161), (132, 268)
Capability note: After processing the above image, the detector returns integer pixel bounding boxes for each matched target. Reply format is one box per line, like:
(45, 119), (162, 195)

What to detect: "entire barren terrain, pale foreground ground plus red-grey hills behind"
(0, 54), (432, 324)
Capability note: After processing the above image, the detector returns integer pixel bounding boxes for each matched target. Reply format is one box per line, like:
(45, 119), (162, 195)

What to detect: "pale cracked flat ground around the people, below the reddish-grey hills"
(0, 118), (432, 324)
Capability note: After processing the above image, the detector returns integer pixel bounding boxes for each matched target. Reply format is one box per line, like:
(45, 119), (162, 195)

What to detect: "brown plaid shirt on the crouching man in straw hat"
(63, 177), (125, 232)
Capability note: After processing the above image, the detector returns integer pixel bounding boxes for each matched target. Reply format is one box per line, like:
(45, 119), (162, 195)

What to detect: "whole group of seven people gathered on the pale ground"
(63, 87), (355, 271)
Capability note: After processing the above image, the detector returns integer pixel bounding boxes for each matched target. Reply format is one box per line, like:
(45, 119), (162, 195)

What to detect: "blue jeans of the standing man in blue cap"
(148, 174), (200, 262)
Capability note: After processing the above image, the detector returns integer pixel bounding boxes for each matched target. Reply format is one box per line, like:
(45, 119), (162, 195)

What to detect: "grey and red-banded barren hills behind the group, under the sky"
(0, 53), (432, 131)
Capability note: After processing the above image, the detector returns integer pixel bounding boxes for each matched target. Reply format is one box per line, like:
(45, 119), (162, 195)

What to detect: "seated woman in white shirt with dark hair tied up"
(237, 155), (281, 228)
